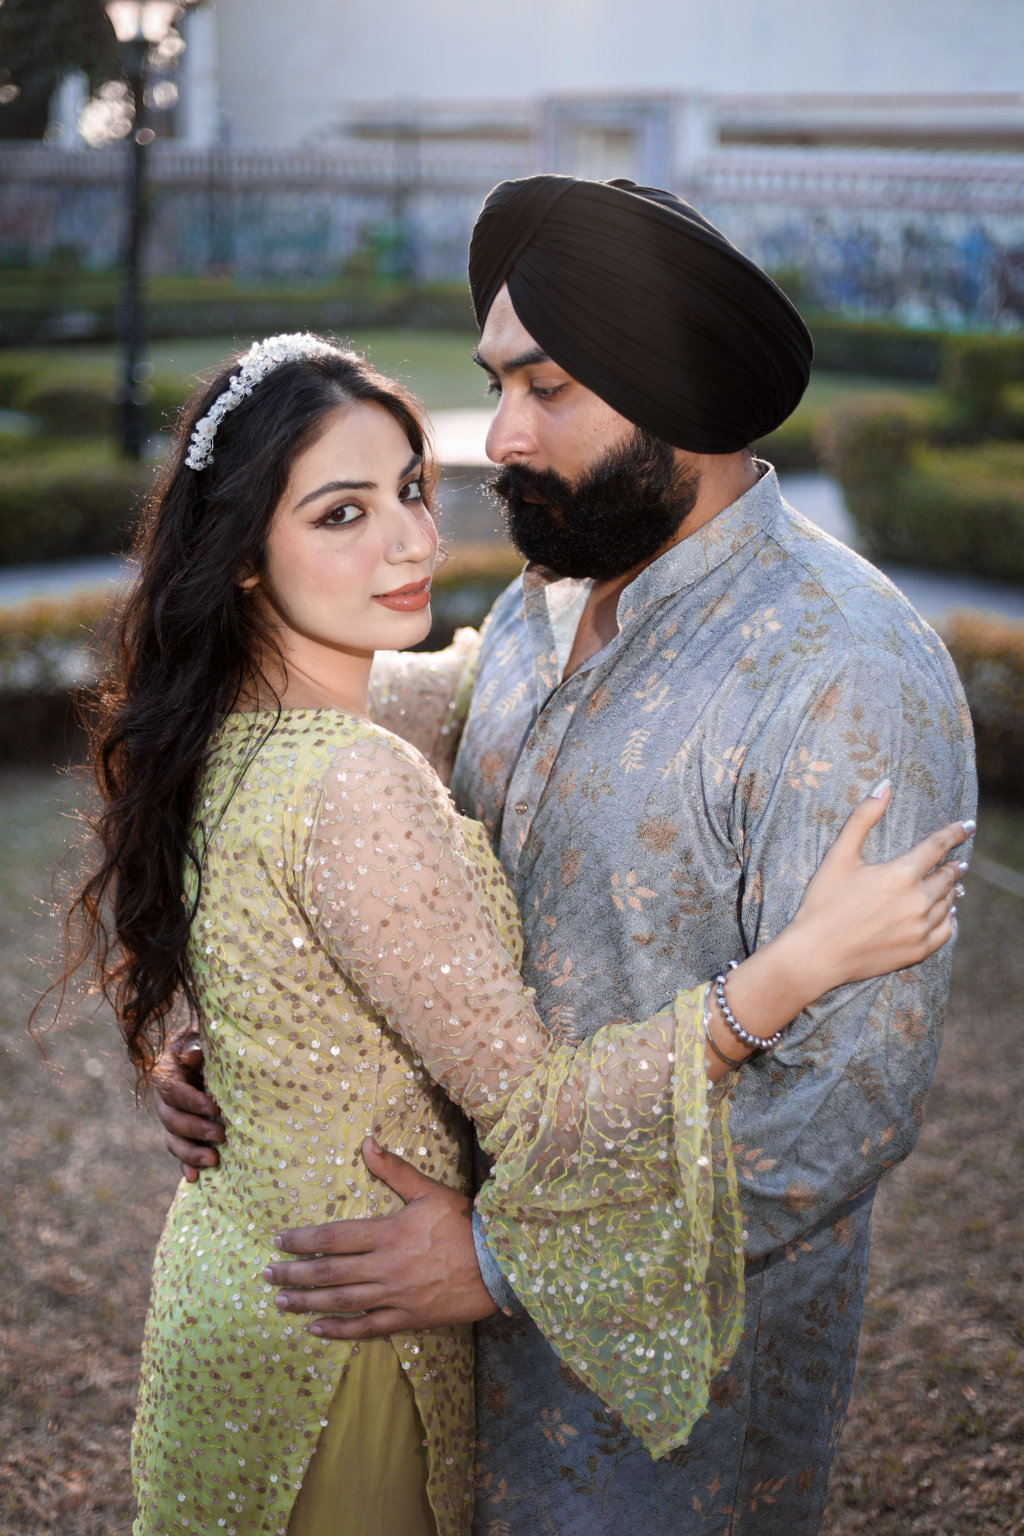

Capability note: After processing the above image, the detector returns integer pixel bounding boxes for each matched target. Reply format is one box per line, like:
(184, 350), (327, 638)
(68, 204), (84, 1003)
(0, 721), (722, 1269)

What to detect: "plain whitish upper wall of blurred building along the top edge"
(204, 0), (1024, 146)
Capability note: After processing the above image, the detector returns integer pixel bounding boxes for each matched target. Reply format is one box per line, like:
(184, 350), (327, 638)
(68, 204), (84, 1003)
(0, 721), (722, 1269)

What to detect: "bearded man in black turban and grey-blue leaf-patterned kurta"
(164, 177), (973, 1536)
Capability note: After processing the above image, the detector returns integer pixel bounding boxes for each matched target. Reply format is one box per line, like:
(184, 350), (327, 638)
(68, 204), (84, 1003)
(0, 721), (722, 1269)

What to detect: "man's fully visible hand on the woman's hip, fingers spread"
(263, 1138), (497, 1339)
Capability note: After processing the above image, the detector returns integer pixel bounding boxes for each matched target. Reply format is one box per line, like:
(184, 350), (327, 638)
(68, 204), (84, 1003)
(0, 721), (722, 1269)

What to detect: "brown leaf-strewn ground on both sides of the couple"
(0, 773), (1024, 1536)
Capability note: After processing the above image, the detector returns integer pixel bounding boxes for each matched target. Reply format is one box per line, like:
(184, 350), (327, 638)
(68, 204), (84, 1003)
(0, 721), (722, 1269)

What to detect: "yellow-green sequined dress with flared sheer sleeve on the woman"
(134, 710), (742, 1536)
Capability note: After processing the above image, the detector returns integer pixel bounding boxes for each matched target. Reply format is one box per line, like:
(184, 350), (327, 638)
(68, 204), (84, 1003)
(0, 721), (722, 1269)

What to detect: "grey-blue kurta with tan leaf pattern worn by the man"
(439, 472), (975, 1536)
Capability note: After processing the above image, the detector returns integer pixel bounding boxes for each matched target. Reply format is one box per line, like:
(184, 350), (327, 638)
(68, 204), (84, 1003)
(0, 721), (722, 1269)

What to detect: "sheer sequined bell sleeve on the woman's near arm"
(306, 733), (743, 1456)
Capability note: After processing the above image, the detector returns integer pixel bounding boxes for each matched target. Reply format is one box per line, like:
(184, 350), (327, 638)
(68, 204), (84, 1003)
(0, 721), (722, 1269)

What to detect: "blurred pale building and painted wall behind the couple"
(0, 0), (1024, 326)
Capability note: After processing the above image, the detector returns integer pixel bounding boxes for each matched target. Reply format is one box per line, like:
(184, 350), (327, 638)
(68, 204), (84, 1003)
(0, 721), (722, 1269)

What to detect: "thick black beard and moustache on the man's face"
(491, 427), (700, 581)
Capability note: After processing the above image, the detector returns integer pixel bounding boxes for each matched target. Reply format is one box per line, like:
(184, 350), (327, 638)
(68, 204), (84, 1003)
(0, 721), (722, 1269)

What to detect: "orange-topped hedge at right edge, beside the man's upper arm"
(943, 613), (1024, 805)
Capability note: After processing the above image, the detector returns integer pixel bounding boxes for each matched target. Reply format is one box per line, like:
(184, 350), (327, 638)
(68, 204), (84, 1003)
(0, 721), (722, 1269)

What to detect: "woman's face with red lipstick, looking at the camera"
(254, 402), (438, 697)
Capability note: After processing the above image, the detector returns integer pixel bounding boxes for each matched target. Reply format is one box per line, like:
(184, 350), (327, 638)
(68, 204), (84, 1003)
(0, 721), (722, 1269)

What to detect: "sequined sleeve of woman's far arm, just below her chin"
(370, 630), (481, 783)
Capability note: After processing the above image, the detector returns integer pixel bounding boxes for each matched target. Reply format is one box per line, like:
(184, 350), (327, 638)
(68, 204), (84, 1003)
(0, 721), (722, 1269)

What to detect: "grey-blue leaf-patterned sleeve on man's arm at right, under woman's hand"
(731, 648), (976, 1255)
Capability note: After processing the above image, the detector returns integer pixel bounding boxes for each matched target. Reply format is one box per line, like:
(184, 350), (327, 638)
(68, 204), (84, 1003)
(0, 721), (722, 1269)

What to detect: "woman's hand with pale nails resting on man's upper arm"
(788, 780), (975, 991)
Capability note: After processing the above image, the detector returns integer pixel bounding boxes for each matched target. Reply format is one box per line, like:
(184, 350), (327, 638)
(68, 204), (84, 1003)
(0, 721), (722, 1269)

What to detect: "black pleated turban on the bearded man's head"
(470, 177), (812, 453)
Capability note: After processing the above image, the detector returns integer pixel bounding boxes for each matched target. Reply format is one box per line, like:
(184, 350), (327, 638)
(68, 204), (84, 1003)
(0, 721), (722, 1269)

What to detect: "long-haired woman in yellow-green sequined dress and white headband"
(66, 336), (964, 1536)
